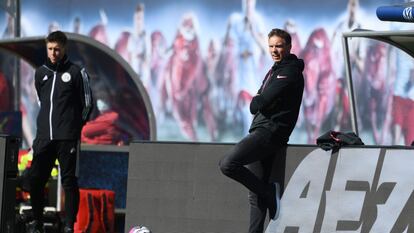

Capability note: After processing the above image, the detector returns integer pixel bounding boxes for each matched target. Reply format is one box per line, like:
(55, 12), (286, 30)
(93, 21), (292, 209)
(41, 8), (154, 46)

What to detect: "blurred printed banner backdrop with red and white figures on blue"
(0, 0), (414, 144)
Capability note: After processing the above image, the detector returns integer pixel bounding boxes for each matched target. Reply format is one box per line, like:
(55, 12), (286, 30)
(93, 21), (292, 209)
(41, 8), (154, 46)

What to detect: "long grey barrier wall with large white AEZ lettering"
(125, 142), (414, 233)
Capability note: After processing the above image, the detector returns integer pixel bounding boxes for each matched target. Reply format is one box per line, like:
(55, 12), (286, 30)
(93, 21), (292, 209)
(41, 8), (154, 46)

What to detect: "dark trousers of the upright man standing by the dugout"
(29, 139), (79, 226)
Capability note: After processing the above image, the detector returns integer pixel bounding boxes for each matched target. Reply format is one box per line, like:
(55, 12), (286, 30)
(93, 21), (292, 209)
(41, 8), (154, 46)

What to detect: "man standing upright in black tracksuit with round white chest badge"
(28, 31), (92, 233)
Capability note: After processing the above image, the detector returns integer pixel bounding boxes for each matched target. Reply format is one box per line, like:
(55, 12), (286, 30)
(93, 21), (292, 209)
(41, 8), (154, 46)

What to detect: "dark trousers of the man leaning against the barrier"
(220, 129), (285, 233)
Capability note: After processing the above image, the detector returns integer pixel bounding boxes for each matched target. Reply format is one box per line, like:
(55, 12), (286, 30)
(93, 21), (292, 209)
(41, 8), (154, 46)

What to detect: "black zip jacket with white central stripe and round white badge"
(35, 56), (92, 140)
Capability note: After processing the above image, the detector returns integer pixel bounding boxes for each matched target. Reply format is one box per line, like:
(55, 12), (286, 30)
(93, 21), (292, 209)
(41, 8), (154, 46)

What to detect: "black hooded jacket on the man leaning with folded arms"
(249, 54), (305, 143)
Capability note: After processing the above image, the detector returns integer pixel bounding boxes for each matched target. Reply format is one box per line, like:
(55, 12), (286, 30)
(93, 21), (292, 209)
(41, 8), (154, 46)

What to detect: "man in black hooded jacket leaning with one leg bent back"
(220, 29), (304, 232)
